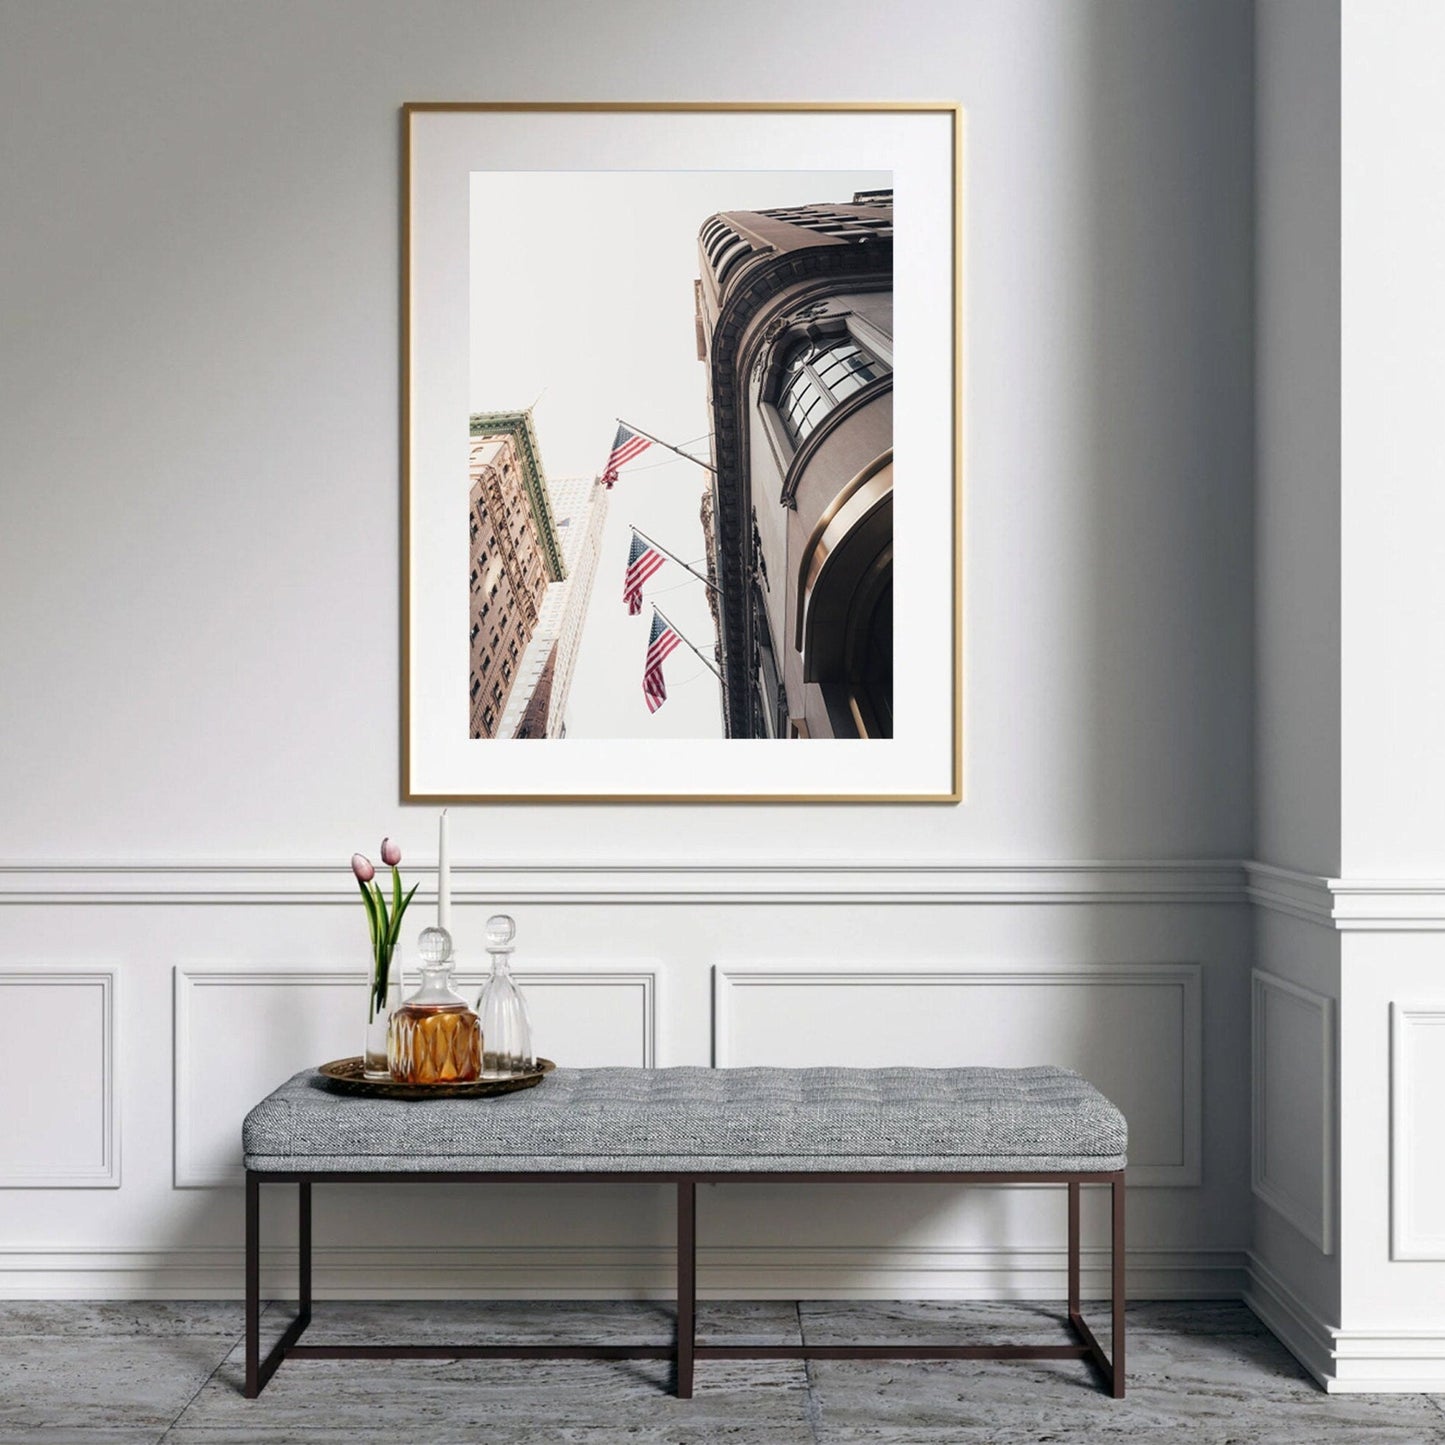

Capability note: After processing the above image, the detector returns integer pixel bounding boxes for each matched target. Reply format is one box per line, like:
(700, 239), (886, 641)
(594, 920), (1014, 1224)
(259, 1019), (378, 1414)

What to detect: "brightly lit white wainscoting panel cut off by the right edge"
(1390, 998), (1445, 1260)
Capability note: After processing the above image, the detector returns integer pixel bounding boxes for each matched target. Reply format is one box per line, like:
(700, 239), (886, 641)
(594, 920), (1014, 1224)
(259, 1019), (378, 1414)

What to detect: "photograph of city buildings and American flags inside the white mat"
(468, 172), (893, 740)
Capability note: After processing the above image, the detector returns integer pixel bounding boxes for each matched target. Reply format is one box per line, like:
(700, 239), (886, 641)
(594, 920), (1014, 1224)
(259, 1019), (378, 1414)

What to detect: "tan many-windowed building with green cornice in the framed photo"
(468, 412), (566, 738)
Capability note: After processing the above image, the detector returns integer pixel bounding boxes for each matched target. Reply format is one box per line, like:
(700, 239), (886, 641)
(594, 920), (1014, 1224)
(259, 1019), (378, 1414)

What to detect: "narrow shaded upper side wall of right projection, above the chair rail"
(1254, 0), (1341, 874)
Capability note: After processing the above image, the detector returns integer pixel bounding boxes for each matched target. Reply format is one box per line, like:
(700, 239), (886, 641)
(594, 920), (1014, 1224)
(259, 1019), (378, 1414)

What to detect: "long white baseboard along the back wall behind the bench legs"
(0, 1246), (1246, 1299)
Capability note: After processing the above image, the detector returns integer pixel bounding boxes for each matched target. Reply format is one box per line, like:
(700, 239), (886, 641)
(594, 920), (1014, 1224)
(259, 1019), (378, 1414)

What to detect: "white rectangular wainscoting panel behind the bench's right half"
(714, 962), (1202, 1186)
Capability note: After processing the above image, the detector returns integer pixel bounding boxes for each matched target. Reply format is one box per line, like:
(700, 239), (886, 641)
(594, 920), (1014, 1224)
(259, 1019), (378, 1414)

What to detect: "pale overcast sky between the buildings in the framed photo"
(462, 171), (890, 738)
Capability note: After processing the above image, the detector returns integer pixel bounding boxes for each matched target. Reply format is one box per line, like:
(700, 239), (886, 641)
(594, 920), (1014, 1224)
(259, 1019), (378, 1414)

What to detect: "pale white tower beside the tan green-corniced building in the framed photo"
(499, 477), (611, 738)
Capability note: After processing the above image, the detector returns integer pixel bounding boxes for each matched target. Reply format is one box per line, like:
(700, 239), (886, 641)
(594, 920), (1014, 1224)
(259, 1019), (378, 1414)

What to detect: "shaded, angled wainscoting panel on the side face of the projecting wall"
(1250, 968), (1335, 1254)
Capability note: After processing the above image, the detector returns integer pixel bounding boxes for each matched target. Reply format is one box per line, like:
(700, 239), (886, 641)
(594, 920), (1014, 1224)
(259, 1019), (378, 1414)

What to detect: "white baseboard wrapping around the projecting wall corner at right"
(1244, 1254), (1445, 1394)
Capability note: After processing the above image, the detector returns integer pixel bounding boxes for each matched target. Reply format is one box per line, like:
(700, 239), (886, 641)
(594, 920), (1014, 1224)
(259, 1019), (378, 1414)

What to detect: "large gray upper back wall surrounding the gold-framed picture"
(0, 0), (1253, 861)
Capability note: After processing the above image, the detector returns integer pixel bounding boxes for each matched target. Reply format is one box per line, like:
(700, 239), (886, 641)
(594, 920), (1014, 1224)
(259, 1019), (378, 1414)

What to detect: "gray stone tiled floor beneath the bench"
(0, 1301), (1445, 1445)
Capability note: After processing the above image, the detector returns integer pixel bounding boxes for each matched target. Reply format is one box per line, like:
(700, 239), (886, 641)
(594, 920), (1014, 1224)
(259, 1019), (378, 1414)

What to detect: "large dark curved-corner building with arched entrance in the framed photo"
(695, 191), (893, 738)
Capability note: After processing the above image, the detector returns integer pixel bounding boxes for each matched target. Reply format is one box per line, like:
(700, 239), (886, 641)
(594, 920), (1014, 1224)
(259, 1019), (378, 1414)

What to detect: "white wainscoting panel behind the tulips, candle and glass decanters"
(173, 964), (657, 1189)
